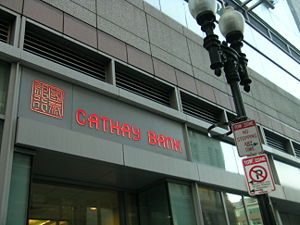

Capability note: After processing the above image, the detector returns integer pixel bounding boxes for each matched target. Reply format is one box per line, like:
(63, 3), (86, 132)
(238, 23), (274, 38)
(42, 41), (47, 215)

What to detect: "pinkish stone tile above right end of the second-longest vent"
(153, 58), (177, 85)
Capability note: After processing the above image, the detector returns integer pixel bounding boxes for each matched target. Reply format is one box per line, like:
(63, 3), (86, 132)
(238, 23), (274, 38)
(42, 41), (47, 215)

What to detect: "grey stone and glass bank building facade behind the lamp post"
(0, 0), (300, 225)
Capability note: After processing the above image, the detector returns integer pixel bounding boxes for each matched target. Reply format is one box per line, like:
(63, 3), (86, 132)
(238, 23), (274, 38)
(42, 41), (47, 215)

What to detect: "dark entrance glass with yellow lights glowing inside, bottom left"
(28, 182), (120, 225)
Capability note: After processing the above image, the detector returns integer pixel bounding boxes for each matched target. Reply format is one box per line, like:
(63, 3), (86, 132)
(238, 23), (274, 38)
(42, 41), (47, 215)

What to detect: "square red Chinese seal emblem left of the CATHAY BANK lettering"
(31, 80), (64, 119)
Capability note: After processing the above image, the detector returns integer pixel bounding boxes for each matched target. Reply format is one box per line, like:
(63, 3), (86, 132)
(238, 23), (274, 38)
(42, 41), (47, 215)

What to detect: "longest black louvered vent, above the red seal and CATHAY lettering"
(24, 24), (108, 81)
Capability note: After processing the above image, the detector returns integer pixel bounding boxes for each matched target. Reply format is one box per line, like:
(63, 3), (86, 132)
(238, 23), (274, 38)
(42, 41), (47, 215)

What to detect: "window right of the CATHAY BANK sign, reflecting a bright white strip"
(188, 129), (244, 174)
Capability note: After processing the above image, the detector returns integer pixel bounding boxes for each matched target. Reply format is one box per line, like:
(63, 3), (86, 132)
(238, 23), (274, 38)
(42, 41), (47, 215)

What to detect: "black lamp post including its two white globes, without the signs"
(189, 0), (276, 225)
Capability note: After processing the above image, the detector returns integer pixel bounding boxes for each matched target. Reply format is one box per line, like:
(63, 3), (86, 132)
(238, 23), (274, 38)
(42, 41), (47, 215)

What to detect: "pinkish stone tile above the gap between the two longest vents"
(98, 31), (127, 62)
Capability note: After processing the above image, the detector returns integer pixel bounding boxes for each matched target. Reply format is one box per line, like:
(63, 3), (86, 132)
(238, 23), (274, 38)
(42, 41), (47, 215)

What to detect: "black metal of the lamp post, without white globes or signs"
(196, 12), (276, 225)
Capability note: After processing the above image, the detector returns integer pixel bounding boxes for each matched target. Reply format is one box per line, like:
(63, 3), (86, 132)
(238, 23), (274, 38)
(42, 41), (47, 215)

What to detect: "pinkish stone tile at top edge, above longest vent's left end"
(23, 0), (63, 32)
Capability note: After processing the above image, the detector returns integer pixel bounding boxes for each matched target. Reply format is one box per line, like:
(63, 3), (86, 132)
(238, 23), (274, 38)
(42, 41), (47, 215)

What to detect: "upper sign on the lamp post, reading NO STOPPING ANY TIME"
(232, 120), (263, 157)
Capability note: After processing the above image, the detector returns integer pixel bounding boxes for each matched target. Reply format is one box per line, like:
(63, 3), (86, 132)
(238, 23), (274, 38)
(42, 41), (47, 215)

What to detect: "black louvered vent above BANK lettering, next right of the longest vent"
(116, 65), (174, 106)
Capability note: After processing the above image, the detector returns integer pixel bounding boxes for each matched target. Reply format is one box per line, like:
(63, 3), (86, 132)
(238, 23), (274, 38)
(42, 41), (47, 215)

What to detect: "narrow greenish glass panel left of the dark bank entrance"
(7, 153), (31, 225)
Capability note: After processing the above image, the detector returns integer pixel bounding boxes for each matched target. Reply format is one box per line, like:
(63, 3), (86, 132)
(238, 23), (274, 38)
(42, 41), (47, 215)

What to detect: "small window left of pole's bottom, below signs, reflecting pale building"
(224, 193), (248, 225)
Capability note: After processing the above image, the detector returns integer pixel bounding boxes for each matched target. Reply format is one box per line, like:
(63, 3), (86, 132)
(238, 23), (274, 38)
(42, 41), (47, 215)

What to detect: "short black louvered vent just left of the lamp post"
(181, 92), (223, 123)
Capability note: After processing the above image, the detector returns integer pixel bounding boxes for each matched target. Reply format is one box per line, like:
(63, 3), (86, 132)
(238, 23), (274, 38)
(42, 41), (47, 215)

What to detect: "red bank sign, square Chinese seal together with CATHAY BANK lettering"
(31, 80), (184, 152)
